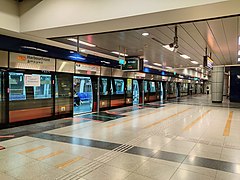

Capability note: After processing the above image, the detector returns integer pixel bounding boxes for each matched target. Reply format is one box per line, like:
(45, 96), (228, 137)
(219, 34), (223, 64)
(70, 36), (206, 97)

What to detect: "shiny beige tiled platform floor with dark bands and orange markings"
(0, 95), (240, 180)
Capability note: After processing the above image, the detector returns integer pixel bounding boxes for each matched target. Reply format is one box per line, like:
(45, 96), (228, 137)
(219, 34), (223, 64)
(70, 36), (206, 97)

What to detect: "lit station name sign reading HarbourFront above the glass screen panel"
(10, 53), (55, 71)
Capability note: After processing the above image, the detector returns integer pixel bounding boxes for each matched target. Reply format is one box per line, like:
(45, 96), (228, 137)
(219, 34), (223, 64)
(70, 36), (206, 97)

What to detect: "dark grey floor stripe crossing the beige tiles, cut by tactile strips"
(31, 133), (239, 174)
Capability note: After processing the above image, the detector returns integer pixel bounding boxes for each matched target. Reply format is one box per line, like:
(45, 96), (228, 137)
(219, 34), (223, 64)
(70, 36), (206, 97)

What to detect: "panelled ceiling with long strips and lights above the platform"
(53, 16), (240, 68)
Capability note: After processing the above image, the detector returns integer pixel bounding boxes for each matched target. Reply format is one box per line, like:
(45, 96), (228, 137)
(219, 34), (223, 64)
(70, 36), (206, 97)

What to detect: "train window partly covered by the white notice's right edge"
(34, 74), (52, 99)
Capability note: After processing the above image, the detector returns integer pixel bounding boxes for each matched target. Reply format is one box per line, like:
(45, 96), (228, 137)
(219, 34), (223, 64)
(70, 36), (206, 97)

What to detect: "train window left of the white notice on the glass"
(9, 72), (26, 101)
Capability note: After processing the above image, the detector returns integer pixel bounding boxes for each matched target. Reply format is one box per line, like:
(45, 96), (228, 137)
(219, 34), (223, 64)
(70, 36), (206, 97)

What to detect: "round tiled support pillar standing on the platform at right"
(212, 67), (224, 103)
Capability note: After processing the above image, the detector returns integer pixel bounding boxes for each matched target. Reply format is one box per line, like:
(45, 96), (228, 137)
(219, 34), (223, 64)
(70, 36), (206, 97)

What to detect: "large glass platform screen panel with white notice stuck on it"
(9, 72), (53, 123)
